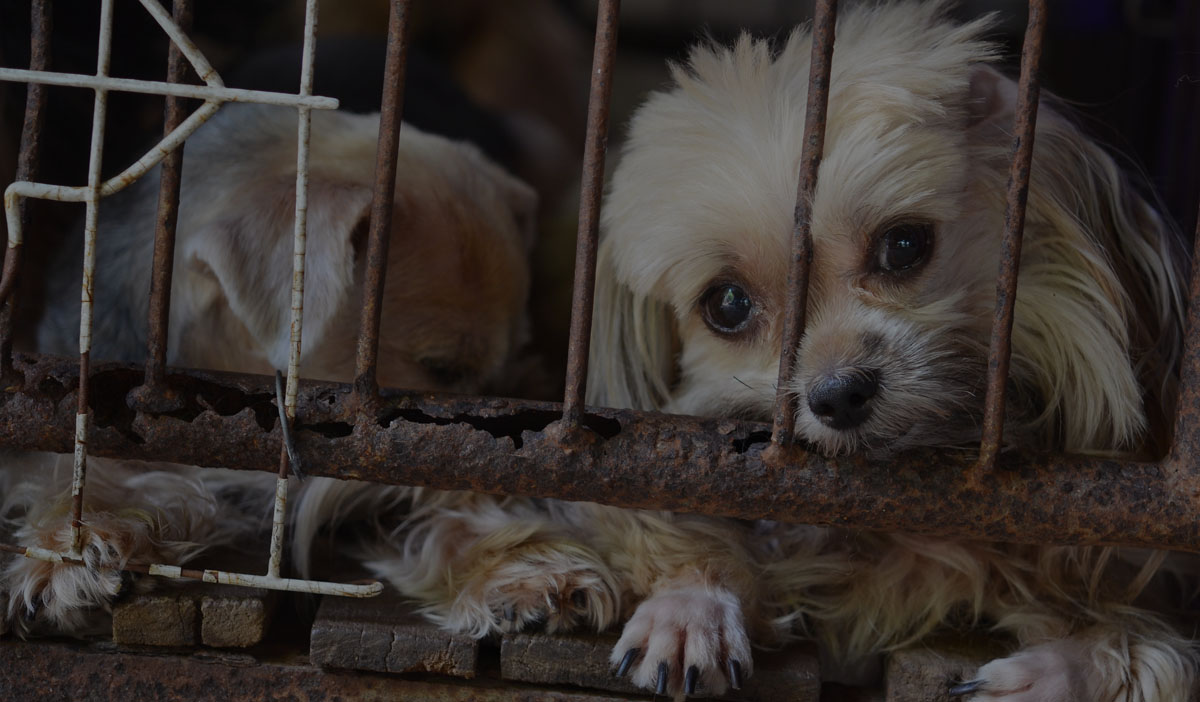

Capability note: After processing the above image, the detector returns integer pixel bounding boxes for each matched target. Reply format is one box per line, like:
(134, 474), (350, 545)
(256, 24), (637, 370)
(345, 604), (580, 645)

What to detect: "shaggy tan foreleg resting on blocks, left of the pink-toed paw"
(293, 479), (618, 636)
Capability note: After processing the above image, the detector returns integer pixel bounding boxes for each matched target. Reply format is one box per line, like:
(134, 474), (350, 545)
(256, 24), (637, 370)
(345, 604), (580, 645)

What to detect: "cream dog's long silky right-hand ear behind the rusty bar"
(967, 66), (1186, 452)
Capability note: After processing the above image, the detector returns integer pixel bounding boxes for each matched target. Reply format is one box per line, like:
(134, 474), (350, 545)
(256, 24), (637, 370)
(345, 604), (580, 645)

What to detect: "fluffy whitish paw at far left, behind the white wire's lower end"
(2, 514), (157, 635)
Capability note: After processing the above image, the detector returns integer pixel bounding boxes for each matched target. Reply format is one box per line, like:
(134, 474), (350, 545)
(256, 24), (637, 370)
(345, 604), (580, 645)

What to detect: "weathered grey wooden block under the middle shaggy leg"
(310, 592), (479, 678)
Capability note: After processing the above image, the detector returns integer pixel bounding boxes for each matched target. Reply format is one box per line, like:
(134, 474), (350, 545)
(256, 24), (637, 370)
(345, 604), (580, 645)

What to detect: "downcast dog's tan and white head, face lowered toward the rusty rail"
(172, 106), (536, 391)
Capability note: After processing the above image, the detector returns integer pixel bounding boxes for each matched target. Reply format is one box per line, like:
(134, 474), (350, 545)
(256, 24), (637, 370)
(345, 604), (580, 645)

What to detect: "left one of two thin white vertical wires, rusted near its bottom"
(71, 0), (113, 554)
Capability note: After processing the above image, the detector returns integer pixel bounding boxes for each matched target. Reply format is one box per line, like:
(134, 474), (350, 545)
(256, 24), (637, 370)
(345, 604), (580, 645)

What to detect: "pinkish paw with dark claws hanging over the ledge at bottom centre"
(611, 587), (752, 696)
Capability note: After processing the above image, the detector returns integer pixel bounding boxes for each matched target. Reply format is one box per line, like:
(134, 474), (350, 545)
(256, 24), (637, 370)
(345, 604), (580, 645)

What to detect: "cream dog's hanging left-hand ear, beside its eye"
(588, 241), (678, 409)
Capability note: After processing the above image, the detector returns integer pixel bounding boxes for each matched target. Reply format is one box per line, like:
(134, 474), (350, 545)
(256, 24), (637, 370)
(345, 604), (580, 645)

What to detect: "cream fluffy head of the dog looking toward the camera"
(592, 2), (1181, 454)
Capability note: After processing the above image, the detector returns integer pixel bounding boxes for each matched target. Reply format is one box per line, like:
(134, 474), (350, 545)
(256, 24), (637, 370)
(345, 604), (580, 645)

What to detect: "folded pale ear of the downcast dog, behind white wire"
(180, 173), (371, 368)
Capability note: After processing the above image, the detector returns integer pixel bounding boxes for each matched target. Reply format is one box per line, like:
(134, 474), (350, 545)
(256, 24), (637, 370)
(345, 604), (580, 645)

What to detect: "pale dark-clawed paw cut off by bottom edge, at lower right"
(950, 638), (1099, 702)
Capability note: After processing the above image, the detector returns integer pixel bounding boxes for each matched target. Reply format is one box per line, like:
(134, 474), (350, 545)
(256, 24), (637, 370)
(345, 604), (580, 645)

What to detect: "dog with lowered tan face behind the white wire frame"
(0, 104), (536, 634)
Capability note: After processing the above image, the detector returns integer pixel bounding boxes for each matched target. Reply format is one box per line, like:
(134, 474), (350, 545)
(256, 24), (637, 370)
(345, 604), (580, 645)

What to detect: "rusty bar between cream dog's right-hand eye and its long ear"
(977, 0), (1046, 470)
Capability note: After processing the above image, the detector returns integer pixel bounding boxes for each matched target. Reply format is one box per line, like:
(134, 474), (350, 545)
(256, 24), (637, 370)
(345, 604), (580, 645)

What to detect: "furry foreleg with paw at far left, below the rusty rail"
(0, 455), (242, 634)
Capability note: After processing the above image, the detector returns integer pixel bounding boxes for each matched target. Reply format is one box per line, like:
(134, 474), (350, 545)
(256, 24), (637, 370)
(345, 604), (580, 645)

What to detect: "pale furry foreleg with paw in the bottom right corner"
(952, 613), (1196, 702)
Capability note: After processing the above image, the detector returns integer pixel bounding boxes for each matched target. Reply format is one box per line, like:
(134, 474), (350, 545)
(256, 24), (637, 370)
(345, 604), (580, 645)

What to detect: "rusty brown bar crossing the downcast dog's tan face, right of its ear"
(354, 0), (412, 402)
